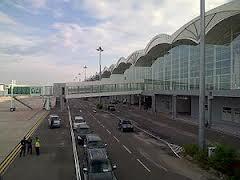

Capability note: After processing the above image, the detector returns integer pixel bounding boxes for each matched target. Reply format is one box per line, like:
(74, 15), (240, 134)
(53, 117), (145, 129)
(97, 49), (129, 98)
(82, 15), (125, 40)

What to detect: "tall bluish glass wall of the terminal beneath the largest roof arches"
(150, 33), (240, 90)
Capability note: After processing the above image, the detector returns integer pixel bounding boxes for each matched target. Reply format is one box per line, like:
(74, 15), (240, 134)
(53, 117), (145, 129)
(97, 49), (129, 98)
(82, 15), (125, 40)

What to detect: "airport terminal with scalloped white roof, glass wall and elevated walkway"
(66, 0), (240, 125)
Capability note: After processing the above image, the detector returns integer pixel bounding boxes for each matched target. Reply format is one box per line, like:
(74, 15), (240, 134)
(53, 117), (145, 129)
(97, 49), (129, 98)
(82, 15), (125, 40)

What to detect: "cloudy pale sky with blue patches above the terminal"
(0, 0), (229, 85)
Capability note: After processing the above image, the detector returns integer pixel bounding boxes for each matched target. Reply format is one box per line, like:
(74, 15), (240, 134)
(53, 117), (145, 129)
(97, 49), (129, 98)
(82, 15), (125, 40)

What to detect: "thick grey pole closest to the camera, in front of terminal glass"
(198, 0), (206, 149)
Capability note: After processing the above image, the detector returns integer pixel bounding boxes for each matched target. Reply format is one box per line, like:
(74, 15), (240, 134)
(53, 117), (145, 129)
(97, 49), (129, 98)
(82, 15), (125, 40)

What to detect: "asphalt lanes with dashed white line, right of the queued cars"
(70, 100), (190, 180)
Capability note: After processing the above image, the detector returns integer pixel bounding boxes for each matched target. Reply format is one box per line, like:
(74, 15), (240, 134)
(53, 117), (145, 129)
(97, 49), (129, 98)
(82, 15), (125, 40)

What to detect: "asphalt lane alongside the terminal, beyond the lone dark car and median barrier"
(80, 100), (240, 149)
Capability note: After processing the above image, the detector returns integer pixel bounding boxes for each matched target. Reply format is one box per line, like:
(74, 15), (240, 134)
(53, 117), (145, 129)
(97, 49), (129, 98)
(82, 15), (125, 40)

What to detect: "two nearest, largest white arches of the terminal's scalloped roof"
(133, 0), (240, 65)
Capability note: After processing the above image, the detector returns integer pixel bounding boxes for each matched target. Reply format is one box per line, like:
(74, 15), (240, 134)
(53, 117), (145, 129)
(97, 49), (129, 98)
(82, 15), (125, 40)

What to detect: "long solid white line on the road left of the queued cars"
(68, 105), (81, 180)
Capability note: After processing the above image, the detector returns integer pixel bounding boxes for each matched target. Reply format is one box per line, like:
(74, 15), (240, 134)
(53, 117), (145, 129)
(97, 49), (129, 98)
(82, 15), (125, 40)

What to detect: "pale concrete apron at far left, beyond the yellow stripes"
(0, 97), (45, 162)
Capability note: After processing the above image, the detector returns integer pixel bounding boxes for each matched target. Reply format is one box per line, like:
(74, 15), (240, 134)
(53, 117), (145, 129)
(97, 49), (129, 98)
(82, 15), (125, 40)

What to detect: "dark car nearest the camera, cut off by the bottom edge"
(83, 149), (117, 180)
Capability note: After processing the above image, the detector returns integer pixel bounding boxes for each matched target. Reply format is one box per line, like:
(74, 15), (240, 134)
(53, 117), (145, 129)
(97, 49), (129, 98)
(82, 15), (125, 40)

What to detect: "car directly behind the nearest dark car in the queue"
(84, 134), (107, 149)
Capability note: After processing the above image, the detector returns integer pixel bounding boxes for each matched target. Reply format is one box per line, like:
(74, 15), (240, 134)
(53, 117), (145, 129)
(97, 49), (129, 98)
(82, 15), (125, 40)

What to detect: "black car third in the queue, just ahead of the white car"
(74, 124), (93, 145)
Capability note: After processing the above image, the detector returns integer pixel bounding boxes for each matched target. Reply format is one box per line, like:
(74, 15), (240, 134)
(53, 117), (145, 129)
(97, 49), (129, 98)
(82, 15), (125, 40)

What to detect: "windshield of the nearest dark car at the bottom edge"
(90, 160), (112, 173)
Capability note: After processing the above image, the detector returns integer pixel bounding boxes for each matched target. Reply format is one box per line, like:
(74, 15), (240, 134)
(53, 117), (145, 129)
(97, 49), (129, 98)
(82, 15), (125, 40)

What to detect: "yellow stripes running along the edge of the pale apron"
(0, 112), (49, 175)
